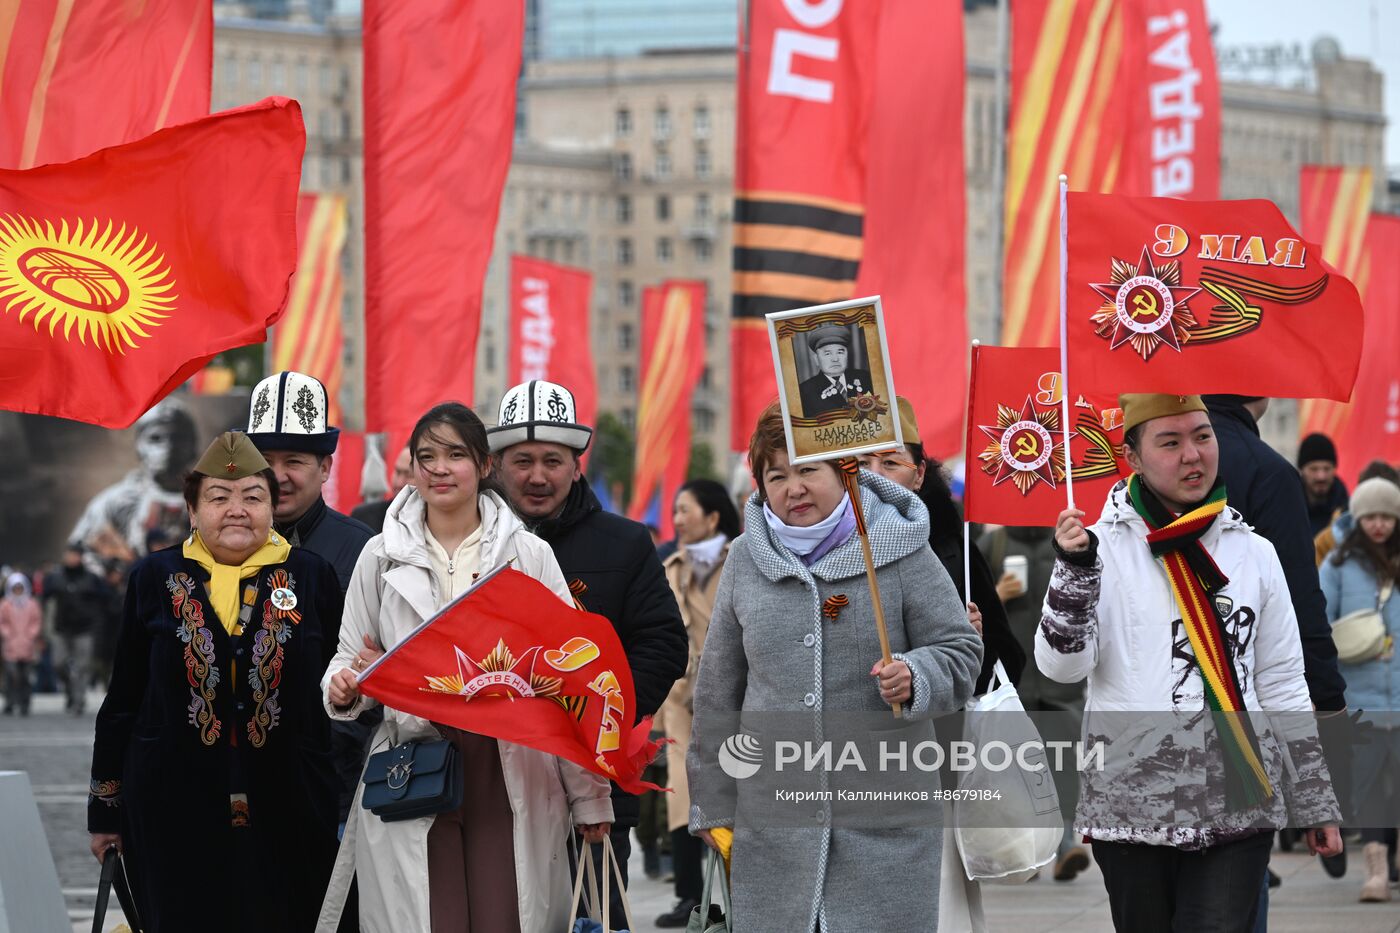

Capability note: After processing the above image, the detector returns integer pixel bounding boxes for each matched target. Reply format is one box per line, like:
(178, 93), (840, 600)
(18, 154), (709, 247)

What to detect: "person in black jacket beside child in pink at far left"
(43, 542), (108, 716)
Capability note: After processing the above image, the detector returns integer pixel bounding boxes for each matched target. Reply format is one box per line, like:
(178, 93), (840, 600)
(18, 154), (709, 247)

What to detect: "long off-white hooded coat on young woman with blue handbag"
(316, 486), (613, 933)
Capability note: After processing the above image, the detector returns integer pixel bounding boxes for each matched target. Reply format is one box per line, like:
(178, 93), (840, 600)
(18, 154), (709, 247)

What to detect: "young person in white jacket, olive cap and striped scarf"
(1036, 395), (1341, 933)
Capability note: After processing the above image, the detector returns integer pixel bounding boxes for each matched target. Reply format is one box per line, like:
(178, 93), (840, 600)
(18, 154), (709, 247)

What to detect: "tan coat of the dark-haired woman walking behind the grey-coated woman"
(657, 544), (729, 829)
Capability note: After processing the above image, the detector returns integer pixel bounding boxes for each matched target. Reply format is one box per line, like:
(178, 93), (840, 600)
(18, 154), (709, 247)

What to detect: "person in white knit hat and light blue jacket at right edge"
(1322, 476), (1400, 902)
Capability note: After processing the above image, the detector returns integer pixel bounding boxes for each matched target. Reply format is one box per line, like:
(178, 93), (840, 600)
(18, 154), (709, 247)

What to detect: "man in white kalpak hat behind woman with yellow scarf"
(248, 371), (384, 825)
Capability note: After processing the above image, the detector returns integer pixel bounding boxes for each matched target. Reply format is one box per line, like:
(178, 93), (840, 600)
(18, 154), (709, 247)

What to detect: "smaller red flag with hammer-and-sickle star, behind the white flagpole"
(963, 346), (1130, 527)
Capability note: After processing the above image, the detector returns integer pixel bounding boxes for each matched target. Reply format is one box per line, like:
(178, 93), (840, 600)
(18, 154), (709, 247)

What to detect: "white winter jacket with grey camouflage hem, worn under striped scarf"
(1036, 482), (1340, 849)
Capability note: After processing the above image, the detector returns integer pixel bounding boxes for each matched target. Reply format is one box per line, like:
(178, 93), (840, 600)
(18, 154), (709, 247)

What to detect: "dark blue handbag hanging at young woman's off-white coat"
(360, 738), (462, 822)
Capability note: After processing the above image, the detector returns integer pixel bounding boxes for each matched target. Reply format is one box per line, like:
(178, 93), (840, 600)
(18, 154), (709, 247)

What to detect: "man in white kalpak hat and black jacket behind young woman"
(487, 380), (690, 926)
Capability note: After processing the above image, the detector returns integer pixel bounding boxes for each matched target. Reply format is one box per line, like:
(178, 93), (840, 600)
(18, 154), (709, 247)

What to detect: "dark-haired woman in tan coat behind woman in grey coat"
(657, 479), (739, 930)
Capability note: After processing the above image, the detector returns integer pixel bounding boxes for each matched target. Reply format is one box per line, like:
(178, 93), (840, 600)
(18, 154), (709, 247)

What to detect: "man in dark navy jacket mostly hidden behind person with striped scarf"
(1204, 395), (1351, 873)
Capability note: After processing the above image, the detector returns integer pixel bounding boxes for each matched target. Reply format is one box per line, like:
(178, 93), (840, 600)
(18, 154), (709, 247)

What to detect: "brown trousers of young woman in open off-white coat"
(428, 726), (521, 933)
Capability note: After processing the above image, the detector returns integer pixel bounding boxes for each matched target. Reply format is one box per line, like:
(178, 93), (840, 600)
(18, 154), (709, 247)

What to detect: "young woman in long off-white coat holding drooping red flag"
(318, 402), (613, 933)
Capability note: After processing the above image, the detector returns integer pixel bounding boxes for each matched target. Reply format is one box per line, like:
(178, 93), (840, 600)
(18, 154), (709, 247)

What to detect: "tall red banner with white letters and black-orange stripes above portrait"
(728, 0), (879, 451)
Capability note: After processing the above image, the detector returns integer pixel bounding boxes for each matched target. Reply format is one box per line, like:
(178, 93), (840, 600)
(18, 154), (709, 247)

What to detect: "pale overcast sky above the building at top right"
(1205, 0), (1400, 165)
